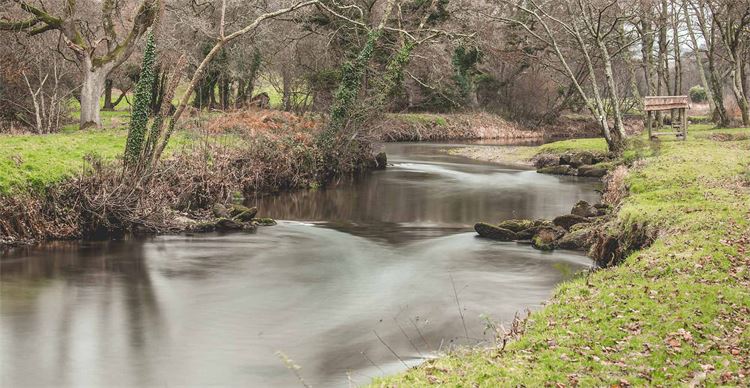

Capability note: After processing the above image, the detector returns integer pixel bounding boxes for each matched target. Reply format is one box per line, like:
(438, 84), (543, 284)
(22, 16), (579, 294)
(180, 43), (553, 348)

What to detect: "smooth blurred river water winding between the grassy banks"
(0, 144), (597, 387)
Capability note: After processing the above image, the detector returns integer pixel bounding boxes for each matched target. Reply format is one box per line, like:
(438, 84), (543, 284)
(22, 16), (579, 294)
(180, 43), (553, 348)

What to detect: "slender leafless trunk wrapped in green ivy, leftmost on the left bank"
(125, 33), (156, 167)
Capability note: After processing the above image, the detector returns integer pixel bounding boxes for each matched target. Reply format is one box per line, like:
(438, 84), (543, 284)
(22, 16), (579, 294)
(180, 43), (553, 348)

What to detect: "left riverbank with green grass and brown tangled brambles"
(0, 111), (385, 245)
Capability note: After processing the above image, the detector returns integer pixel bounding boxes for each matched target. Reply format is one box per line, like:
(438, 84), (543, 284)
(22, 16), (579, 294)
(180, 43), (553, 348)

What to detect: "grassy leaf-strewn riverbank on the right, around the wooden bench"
(373, 126), (750, 386)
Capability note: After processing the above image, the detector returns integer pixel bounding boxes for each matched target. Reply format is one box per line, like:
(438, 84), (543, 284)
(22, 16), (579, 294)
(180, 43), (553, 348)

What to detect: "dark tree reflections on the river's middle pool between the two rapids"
(249, 171), (593, 227)
